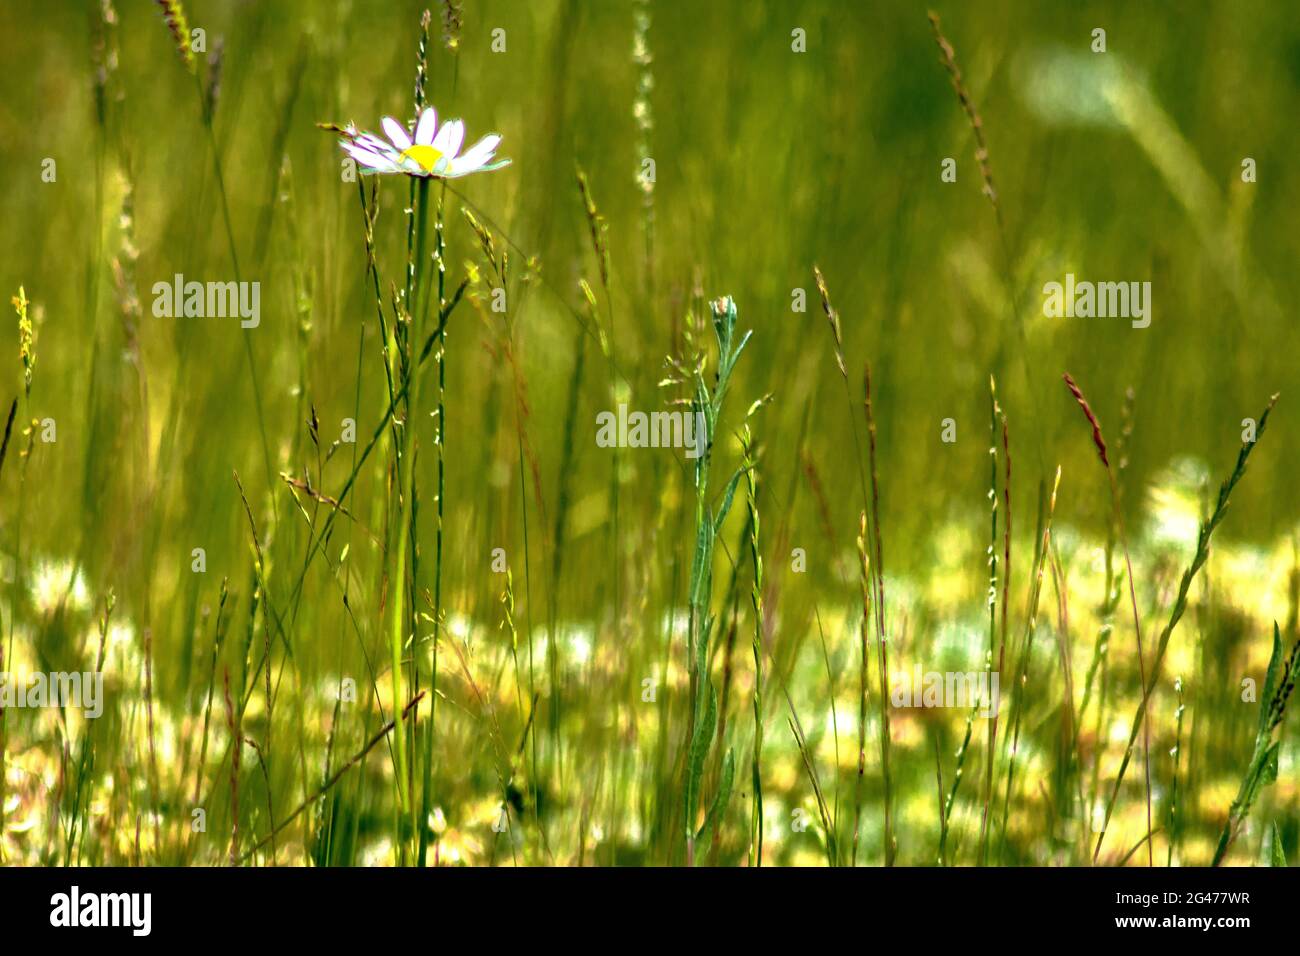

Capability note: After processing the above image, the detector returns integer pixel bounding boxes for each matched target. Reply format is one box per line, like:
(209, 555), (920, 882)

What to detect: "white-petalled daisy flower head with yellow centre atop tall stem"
(339, 107), (510, 179)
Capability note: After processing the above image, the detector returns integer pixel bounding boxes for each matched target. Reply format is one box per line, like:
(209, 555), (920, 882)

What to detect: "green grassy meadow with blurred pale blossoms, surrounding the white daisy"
(0, 0), (1300, 866)
